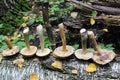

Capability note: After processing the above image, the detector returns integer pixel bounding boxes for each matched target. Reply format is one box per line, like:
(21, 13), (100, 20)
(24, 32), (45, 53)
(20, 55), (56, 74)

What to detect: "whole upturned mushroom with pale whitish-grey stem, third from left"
(36, 25), (51, 57)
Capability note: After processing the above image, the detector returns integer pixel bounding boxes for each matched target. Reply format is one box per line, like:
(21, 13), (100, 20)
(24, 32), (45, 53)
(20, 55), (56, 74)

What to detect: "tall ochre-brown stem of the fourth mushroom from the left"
(59, 23), (67, 52)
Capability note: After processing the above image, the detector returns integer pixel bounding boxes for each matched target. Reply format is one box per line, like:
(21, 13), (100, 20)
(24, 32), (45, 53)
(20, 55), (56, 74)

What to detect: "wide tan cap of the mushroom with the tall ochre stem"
(53, 45), (75, 59)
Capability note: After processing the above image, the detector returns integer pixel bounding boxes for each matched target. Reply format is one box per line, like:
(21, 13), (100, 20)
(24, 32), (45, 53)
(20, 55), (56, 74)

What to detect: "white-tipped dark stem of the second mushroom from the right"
(80, 29), (88, 54)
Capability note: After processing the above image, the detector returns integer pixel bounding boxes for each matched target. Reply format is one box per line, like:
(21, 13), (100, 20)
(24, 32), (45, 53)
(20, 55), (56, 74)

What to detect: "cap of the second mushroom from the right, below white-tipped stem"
(75, 49), (93, 60)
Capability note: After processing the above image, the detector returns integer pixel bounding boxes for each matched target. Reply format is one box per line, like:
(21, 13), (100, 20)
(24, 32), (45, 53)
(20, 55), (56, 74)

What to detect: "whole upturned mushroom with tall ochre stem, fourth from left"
(53, 23), (75, 59)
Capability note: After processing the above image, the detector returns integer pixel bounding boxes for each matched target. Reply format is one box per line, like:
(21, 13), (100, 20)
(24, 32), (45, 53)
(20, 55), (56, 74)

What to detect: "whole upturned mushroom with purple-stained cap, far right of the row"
(88, 31), (116, 65)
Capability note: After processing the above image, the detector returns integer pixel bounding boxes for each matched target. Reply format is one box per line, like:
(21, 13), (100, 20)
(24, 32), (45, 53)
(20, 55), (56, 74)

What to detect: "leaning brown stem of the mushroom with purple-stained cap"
(88, 31), (101, 55)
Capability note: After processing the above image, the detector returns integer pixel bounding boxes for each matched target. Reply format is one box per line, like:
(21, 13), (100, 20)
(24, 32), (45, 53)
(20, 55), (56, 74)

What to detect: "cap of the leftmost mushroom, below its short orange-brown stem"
(2, 46), (19, 57)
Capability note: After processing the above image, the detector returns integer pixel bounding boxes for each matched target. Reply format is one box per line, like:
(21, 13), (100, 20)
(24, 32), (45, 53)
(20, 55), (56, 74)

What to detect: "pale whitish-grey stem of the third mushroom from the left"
(37, 25), (44, 51)
